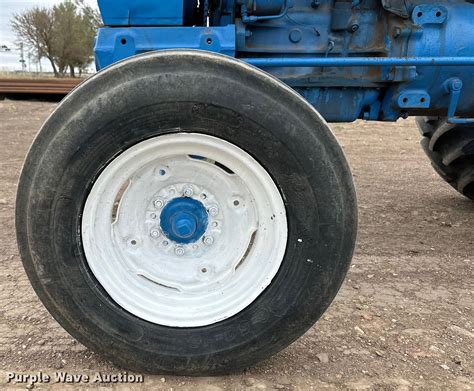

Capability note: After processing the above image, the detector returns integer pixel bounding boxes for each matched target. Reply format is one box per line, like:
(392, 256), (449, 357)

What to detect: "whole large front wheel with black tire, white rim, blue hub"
(16, 50), (357, 376)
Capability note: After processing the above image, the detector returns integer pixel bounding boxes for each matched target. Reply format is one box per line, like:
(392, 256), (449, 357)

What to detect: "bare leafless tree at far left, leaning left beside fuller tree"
(11, 7), (59, 76)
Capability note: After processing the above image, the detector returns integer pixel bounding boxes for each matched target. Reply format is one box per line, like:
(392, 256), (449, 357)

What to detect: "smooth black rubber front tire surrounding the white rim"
(17, 52), (356, 374)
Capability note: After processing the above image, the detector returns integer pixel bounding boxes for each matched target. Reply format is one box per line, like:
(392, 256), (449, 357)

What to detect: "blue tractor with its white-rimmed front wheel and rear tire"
(17, 0), (474, 375)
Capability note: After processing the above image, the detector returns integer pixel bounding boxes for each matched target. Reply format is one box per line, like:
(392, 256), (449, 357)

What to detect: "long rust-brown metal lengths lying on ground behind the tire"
(0, 79), (84, 95)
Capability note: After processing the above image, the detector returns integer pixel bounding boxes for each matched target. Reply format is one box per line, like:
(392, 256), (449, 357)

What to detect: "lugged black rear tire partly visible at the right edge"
(417, 117), (474, 200)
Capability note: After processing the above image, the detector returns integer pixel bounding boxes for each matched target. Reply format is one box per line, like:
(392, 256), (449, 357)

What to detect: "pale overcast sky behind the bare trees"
(0, 0), (97, 72)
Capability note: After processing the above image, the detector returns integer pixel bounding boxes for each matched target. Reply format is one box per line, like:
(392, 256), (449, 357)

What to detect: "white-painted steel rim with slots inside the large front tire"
(82, 133), (288, 327)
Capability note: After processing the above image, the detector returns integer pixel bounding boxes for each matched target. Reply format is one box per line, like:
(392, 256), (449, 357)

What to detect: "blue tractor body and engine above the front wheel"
(95, 0), (474, 122)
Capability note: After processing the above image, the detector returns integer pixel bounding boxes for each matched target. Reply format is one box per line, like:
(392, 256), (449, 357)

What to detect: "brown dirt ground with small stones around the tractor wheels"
(0, 100), (474, 390)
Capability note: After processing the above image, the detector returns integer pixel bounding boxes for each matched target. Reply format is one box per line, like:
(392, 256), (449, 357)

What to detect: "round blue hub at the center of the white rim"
(160, 197), (208, 244)
